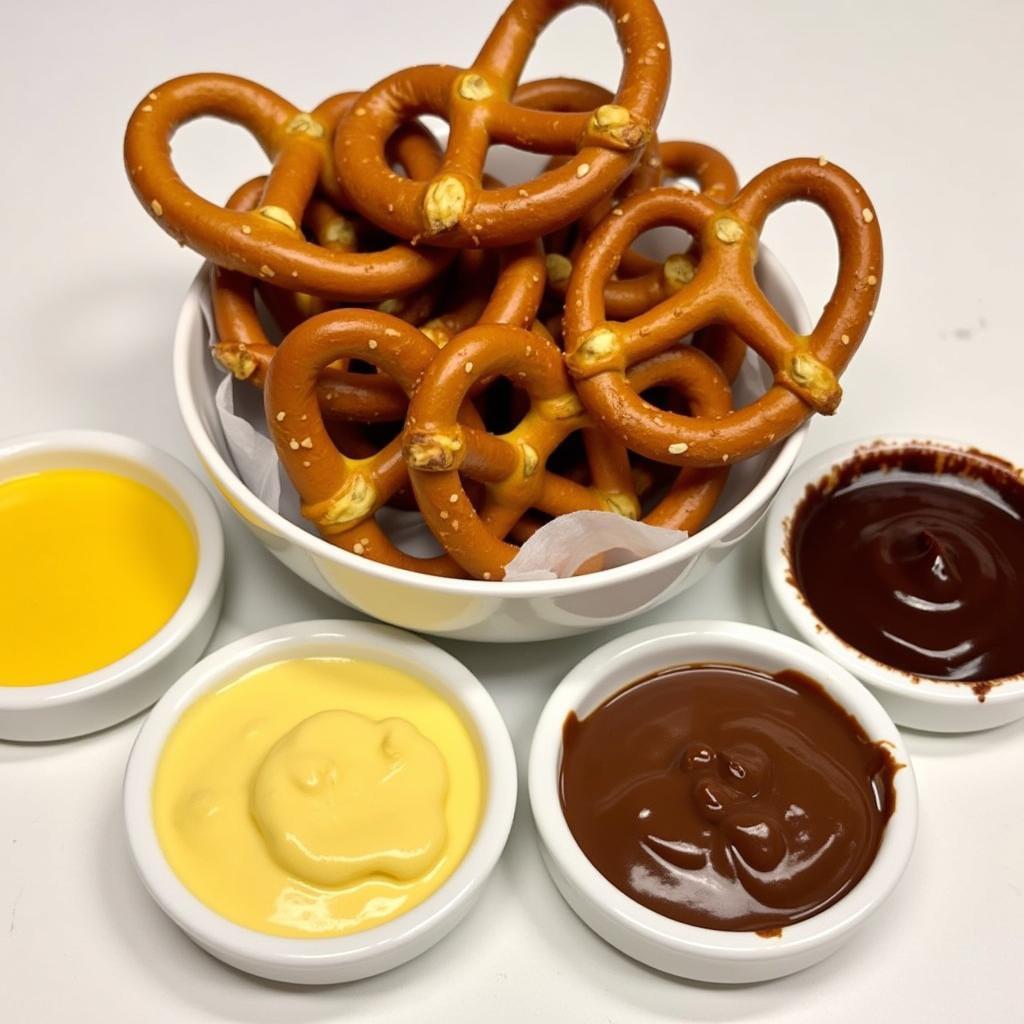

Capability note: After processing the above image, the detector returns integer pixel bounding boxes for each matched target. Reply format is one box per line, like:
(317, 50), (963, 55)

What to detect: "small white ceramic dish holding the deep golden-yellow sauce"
(0, 430), (224, 740)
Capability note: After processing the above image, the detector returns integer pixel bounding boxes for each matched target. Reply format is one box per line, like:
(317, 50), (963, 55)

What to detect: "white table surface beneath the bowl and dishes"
(0, 0), (1024, 1024)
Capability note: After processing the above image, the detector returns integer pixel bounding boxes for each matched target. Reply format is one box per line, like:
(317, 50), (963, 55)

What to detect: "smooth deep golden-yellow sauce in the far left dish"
(0, 469), (197, 686)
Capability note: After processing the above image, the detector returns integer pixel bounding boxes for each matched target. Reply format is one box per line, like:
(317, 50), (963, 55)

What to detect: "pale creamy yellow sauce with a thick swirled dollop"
(153, 658), (485, 938)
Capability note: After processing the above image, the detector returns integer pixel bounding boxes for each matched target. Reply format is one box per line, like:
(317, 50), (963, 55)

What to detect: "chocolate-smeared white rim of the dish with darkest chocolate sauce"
(763, 434), (1024, 707)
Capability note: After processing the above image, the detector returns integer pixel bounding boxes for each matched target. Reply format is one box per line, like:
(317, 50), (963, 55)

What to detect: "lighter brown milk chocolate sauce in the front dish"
(561, 665), (898, 936)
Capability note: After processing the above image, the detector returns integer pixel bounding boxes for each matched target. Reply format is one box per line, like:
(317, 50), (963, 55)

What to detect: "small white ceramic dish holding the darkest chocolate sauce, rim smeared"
(763, 435), (1024, 732)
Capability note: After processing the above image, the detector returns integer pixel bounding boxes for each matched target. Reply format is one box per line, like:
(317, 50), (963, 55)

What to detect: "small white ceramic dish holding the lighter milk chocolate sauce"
(529, 622), (918, 982)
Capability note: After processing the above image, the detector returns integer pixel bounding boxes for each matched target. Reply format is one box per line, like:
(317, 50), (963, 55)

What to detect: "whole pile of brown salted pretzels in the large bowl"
(125, 0), (882, 580)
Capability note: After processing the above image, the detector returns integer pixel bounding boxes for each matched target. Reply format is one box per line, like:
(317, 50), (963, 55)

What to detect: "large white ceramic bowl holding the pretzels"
(174, 251), (809, 643)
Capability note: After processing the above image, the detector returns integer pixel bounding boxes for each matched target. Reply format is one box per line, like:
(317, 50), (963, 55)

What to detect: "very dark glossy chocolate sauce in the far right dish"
(790, 446), (1024, 698)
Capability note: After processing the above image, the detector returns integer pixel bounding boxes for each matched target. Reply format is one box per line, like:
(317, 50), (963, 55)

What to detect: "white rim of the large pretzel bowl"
(174, 246), (810, 597)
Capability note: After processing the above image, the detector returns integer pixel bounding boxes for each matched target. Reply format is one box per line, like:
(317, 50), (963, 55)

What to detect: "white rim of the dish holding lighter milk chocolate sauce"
(528, 620), (918, 962)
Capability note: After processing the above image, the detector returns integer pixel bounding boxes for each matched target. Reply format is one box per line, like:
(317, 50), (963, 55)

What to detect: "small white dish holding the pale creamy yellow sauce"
(124, 620), (516, 985)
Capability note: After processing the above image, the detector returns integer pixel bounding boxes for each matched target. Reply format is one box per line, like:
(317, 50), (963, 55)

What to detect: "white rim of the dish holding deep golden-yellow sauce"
(0, 430), (224, 711)
